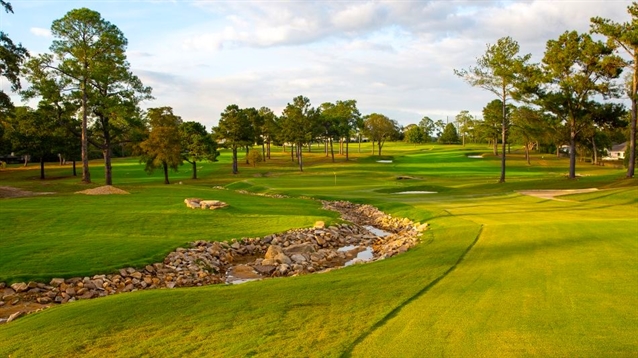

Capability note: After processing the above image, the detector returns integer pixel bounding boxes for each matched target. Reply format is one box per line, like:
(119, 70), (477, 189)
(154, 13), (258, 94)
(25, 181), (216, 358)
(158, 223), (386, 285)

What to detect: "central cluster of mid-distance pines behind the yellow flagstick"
(213, 96), (399, 174)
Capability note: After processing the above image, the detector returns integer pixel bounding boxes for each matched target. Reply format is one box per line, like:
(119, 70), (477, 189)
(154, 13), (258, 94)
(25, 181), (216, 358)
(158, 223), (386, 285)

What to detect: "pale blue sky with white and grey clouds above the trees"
(0, 0), (630, 128)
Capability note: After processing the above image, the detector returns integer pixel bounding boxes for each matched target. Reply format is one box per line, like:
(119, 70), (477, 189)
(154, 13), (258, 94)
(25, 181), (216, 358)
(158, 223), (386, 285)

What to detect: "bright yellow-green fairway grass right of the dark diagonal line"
(353, 199), (638, 357)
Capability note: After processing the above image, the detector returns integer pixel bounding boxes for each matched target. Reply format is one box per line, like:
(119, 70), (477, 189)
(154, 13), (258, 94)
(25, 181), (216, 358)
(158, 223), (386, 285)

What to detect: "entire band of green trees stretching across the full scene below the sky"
(0, 1), (638, 185)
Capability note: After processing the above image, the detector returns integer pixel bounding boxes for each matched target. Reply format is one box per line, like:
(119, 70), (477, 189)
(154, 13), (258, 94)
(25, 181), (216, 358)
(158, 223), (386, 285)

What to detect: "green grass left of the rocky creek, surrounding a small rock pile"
(0, 185), (337, 282)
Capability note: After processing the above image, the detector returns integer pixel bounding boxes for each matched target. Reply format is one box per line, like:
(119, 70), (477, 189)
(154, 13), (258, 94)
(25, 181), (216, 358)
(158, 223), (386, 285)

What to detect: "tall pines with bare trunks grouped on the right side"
(454, 3), (638, 182)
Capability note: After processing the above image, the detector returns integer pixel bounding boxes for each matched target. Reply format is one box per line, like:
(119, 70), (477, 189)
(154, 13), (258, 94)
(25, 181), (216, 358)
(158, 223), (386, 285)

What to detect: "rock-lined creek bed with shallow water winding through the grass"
(0, 201), (427, 323)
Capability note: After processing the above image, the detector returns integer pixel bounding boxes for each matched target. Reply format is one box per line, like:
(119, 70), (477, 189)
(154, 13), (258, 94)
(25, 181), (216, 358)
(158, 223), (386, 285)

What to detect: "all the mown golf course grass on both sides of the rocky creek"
(0, 143), (638, 357)
